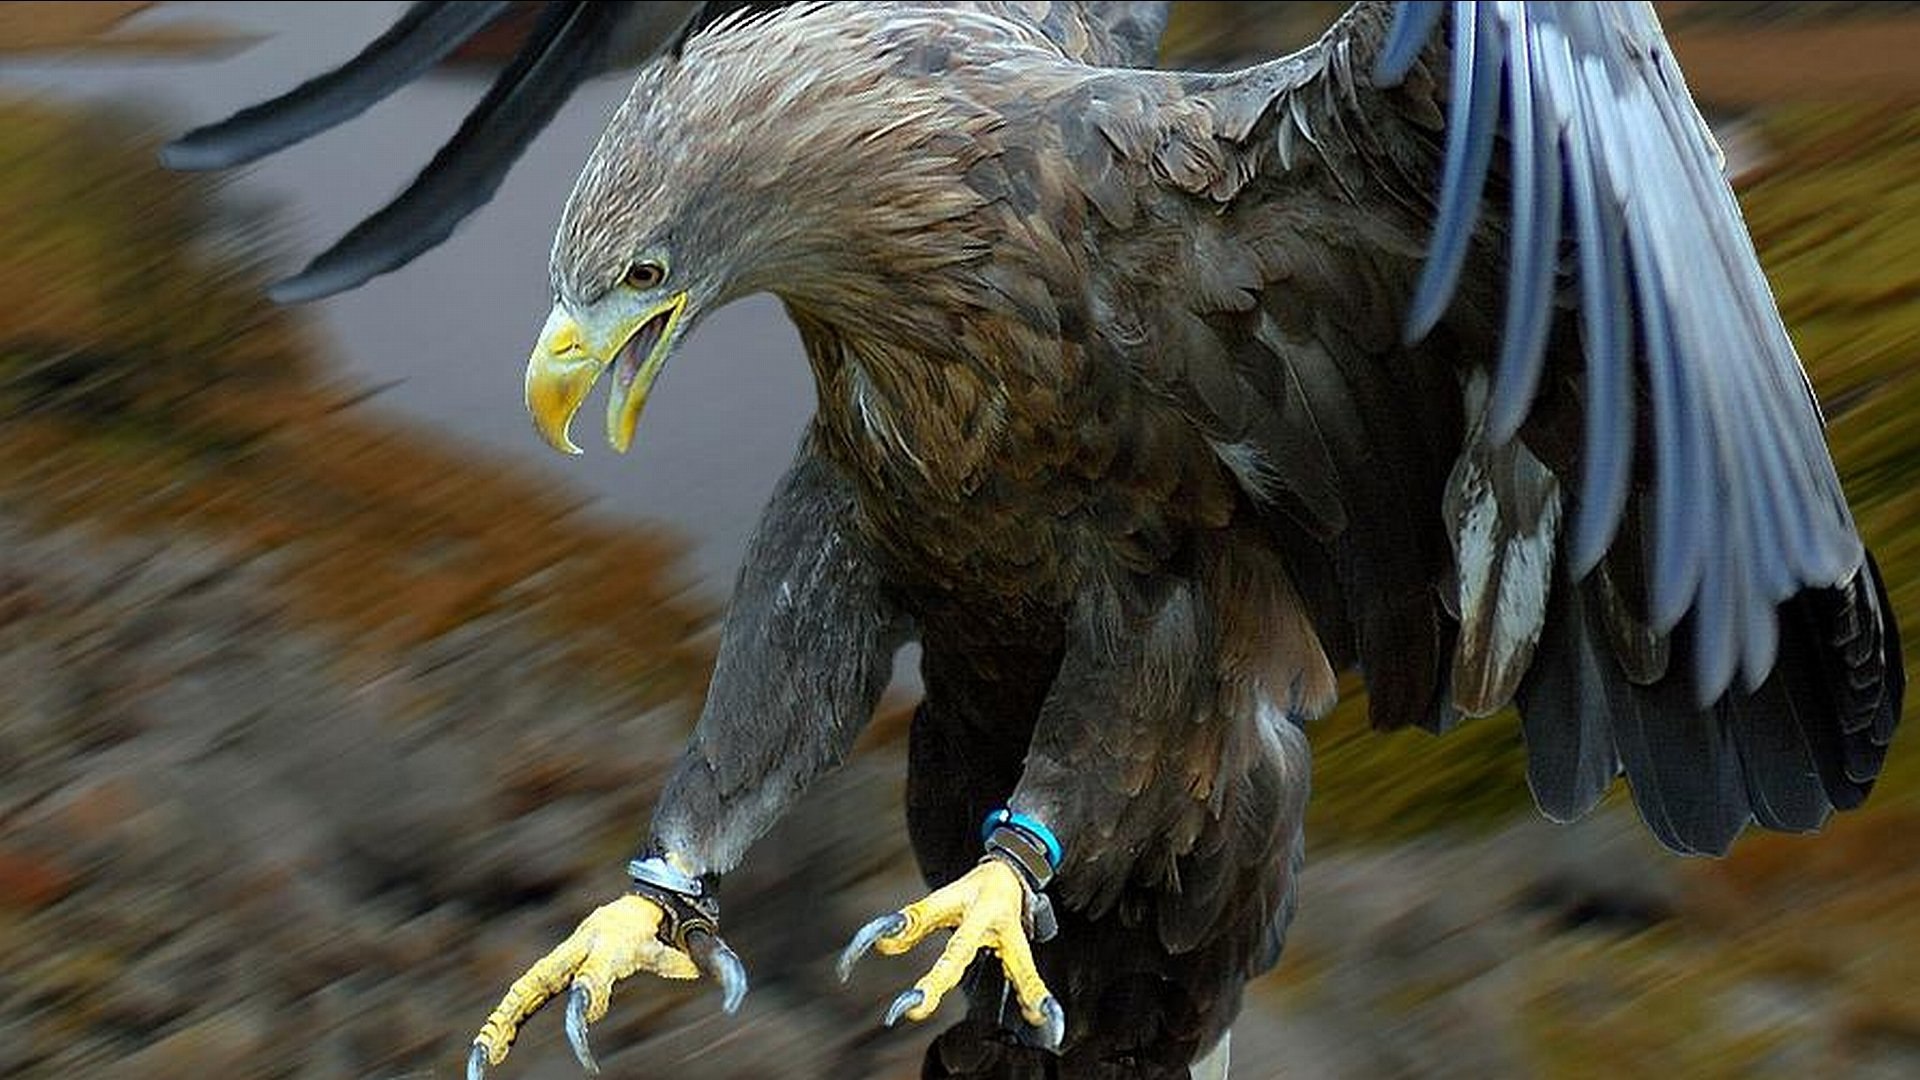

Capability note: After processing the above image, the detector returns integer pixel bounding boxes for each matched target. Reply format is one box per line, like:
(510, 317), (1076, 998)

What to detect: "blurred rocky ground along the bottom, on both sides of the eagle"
(0, 517), (1920, 1080)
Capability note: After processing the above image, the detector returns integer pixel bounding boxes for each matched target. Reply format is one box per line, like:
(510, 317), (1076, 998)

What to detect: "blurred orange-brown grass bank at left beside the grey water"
(0, 100), (712, 705)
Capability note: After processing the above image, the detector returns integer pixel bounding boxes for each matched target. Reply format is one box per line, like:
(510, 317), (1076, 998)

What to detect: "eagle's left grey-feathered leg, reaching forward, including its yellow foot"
(468, 442), (904, 1078)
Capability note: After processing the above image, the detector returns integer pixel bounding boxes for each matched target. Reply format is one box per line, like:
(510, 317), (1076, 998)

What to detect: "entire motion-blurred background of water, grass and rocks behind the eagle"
(0, 2), (1920, 1078)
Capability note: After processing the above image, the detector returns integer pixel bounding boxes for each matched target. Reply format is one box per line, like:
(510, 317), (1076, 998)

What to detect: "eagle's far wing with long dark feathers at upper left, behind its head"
(161, 0), (1167, 304)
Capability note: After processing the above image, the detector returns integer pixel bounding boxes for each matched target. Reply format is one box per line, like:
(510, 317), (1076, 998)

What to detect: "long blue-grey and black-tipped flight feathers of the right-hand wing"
(1373, 4), (1903, 851)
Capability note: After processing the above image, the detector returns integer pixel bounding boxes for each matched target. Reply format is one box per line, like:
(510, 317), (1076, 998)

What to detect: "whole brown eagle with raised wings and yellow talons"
(167, 2), (1903, 1080)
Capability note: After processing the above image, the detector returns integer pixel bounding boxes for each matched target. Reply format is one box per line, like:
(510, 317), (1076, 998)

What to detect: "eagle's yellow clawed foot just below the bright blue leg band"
(839, 859), (1066, 1049)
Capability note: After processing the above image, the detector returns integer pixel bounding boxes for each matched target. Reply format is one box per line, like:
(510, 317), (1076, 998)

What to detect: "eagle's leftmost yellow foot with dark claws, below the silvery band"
(467, 896), (747, 1080)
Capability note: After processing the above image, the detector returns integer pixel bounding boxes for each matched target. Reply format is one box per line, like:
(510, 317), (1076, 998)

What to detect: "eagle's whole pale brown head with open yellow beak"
(526, 4), (998, 454)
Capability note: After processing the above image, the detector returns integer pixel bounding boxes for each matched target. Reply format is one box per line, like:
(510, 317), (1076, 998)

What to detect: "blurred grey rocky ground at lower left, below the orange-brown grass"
(0, 517), (936, 1078)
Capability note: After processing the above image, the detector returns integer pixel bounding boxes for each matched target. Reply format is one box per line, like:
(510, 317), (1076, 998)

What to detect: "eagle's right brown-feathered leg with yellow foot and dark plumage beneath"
(856, 534), (1332, 1080)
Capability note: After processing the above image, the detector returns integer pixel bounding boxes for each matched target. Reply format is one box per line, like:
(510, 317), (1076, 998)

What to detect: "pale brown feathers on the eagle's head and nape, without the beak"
(551, 4), (1031, 328)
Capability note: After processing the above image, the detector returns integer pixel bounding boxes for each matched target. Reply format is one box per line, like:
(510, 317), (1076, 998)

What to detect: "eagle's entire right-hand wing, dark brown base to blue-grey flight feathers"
(1079, 2), (1903, 851)
